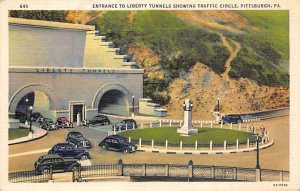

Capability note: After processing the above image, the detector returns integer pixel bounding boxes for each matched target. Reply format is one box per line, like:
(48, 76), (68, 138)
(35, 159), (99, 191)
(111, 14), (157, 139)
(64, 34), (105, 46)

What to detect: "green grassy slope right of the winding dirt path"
(230, 11), (289, 86)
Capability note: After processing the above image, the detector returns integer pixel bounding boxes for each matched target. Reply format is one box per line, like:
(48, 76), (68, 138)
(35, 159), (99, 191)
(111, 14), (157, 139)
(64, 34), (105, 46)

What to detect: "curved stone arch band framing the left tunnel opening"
(8, 84), (62, 114)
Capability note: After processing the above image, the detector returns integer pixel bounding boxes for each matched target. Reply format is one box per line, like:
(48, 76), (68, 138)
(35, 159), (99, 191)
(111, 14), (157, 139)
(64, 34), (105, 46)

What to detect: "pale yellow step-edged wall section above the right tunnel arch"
(83, 31), (137, 69)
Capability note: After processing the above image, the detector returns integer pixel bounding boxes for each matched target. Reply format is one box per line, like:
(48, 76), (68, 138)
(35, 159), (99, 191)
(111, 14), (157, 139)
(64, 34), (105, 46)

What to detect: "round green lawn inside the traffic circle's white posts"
(119, 127), (255, 146)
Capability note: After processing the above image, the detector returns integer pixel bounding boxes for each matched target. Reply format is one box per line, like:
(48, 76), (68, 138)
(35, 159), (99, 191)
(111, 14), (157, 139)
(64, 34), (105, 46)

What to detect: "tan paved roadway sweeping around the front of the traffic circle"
(9, 117), (289, 172)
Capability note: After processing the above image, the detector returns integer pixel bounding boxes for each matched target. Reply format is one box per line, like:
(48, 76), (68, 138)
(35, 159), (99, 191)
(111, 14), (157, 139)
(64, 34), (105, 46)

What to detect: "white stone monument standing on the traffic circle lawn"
(177, 99), (198, 135)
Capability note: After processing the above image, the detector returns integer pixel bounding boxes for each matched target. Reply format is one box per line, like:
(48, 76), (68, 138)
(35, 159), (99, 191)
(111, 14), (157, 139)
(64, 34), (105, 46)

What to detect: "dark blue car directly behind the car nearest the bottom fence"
(48, 143), (90, 160)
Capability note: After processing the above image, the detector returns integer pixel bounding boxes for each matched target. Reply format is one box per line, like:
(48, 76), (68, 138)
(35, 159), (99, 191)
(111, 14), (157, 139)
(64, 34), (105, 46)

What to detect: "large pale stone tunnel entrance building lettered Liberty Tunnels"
(8, 18), (144, 122)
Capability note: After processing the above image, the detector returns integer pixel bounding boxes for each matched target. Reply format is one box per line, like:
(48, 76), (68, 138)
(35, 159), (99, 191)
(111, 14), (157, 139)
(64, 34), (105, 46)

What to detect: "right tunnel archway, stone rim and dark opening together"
(92, 84), (132, 116)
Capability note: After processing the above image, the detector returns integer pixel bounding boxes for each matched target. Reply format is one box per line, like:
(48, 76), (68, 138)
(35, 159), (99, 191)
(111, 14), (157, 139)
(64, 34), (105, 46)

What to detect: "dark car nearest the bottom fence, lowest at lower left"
(34, 154), (80, 174)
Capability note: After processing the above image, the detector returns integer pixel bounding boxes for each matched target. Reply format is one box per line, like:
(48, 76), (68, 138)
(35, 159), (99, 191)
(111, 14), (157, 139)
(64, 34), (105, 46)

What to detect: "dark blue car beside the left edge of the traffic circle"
(99, 135), (138, 153)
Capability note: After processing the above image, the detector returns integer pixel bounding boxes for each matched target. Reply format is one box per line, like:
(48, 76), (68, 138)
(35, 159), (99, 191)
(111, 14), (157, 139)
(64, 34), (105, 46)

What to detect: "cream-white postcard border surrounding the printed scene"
(0, 0), (300, 191)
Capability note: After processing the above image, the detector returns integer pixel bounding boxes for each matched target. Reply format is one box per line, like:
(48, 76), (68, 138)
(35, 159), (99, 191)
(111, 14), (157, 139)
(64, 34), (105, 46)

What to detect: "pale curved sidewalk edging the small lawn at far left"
(8, 124), (48, 145)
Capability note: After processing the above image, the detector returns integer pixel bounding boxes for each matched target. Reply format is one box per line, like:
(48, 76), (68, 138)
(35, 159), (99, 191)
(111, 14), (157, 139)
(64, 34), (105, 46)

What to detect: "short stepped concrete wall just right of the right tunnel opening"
(139, 98), (168, 117)
